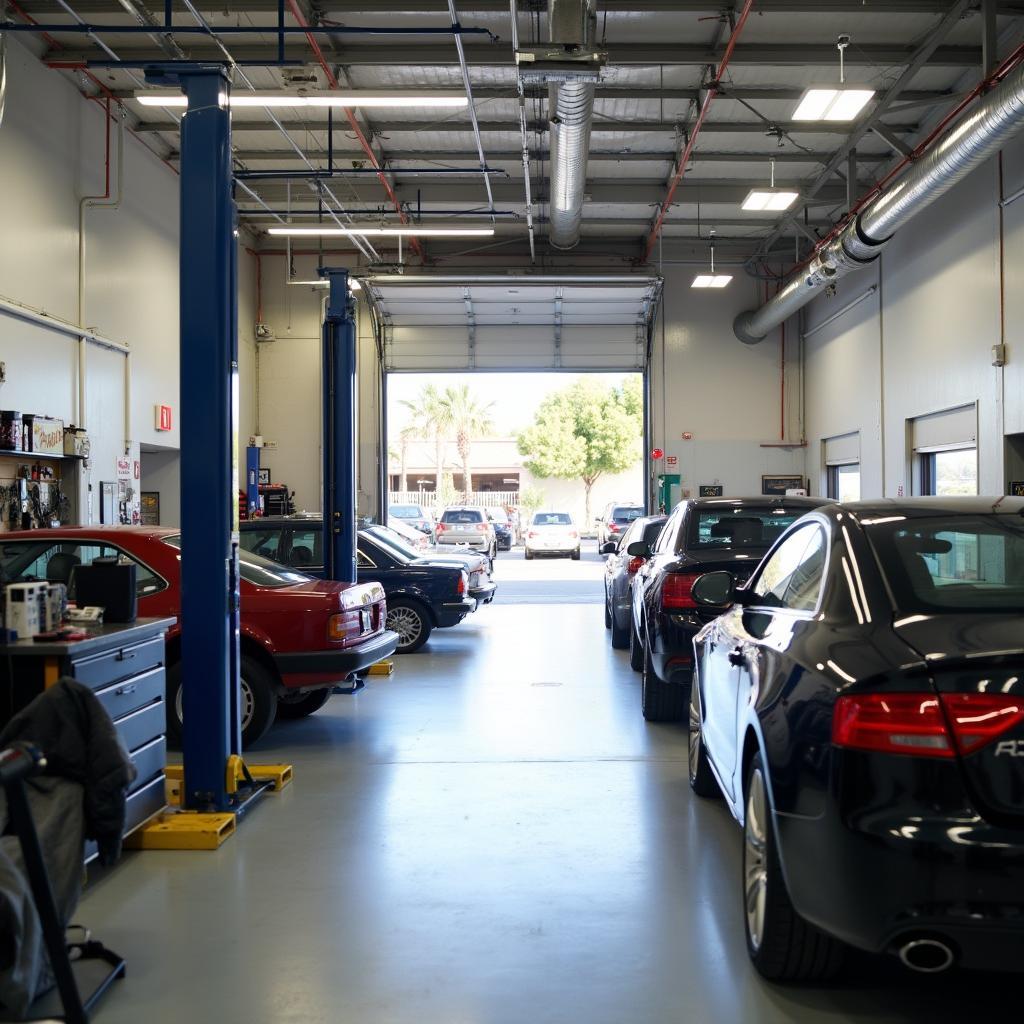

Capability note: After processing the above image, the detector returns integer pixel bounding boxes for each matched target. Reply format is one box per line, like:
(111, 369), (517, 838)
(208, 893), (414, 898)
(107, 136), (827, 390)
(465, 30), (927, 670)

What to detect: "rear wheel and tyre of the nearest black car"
(741, 753), (845, 982)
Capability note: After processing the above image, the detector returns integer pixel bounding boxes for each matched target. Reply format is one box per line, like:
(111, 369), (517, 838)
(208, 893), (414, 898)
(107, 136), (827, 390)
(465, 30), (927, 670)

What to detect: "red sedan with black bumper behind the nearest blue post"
(0, 526), (398, 746)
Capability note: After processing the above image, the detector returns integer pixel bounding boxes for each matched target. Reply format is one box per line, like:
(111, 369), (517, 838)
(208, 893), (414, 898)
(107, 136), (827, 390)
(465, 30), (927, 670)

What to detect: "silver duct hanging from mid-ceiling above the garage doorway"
(548, 0), (597, 249)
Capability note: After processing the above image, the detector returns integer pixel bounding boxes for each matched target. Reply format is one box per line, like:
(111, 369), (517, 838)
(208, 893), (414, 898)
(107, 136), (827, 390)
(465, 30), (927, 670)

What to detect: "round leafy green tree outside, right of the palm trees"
(517, 381), (643, 524)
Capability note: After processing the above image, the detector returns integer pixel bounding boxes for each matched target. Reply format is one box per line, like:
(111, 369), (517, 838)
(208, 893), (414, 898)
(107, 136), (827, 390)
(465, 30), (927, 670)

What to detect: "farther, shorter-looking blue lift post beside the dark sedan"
(321, 267), (356, 583)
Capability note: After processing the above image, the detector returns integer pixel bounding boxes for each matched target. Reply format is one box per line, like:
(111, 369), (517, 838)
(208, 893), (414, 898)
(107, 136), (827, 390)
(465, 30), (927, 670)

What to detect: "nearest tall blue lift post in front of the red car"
(146, 66), (242, 811)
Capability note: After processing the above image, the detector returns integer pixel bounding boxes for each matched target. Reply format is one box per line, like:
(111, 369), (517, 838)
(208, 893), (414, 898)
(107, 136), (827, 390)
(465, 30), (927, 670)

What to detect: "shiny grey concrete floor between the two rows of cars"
(77, 552), (1017, 1024)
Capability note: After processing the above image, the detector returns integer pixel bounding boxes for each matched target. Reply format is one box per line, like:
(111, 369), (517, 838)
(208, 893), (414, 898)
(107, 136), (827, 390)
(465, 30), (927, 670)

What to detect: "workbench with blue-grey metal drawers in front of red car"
(0, 618), (175, 860)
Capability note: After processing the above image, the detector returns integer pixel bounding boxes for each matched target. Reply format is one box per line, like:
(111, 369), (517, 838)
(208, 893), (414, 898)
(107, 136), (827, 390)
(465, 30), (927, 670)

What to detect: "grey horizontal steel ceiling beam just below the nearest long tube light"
(135, 115), (919, 135)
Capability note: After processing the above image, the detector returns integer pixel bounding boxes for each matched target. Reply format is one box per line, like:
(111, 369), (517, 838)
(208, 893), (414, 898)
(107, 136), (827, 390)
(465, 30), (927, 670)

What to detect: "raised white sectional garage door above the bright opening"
(365, 274), (662, 372)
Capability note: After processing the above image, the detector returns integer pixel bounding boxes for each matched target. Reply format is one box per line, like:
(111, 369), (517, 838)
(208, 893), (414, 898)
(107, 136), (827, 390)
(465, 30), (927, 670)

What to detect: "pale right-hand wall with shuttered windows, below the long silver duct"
(806, 132), (1024, 497)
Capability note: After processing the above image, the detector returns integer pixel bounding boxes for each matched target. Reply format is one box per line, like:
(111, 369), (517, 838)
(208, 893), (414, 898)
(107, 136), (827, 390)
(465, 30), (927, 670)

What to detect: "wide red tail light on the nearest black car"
(833, 693), (1024, 758)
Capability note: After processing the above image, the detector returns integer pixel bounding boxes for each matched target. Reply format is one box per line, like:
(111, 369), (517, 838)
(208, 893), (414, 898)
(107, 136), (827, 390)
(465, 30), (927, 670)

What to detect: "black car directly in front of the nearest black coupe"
(627, 495), (824, 722)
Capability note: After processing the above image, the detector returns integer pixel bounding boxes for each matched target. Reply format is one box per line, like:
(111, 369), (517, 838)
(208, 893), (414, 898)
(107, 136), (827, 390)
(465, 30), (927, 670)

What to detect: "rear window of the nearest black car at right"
(865, 514), (1024, 612)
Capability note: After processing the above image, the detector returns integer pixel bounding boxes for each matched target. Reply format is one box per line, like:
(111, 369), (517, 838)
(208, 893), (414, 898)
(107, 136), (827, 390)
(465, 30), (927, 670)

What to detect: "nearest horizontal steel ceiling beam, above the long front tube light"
(43, 40), (981, 69)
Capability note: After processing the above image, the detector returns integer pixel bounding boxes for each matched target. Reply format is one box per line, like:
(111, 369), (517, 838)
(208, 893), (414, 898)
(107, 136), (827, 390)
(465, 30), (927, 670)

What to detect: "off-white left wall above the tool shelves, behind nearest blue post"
(0, 40), (255, 518)
